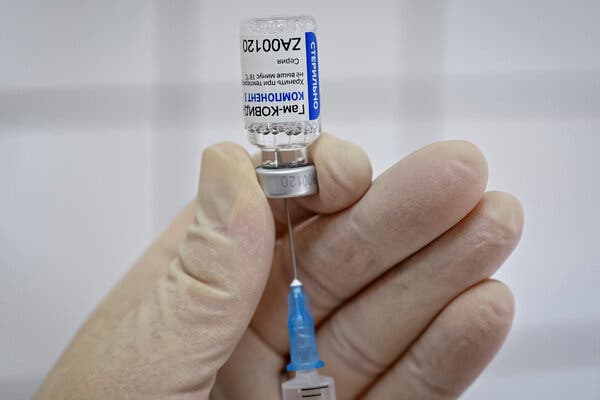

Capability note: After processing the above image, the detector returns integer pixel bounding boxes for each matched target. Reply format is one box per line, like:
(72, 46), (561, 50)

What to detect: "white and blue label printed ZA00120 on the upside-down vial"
(241, 32), (321, 125)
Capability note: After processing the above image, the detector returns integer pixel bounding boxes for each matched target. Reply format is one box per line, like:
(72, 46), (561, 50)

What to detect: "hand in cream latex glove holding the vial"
(35, 134), (523, 400)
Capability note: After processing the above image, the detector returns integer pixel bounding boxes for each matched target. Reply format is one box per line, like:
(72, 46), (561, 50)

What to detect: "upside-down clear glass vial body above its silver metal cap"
(240, 16), (321, 168)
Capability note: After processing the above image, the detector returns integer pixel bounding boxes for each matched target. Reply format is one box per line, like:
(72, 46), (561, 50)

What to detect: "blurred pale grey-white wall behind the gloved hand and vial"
(0, 0), (600, 399)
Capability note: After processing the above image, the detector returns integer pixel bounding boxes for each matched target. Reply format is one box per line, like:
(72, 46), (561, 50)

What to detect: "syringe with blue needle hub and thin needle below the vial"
(281, 200), (335, 400)
